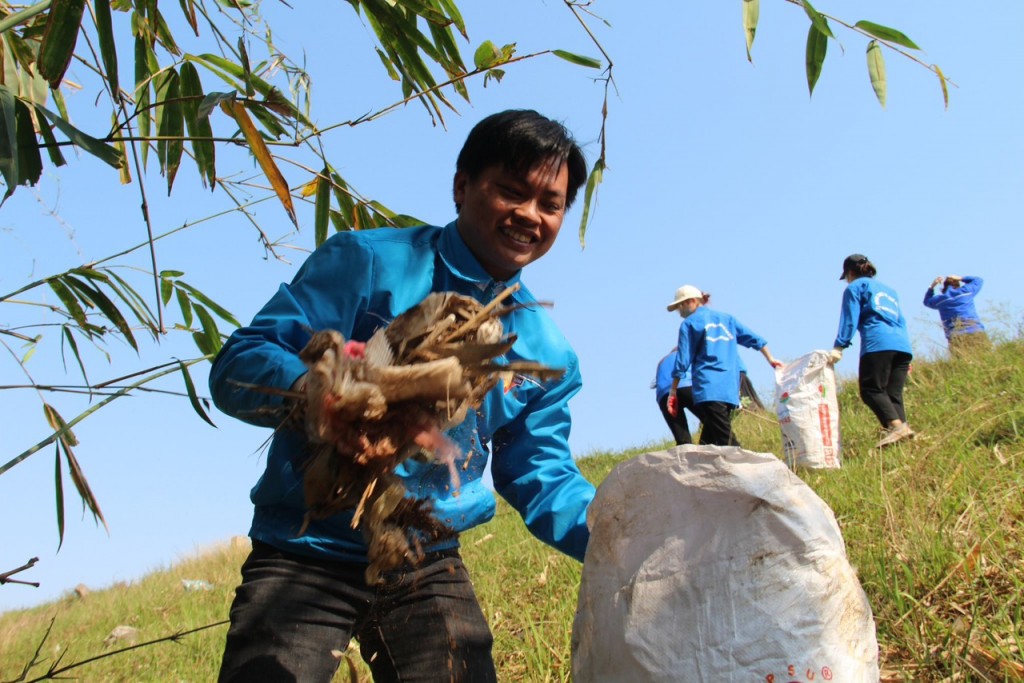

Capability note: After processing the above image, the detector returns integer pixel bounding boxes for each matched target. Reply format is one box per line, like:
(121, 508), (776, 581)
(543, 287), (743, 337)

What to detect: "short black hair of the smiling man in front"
(455, 110), (587, 208)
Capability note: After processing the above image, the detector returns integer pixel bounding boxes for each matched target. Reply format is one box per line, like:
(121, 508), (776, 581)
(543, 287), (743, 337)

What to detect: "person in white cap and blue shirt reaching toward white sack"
(668, 285), (782, 445)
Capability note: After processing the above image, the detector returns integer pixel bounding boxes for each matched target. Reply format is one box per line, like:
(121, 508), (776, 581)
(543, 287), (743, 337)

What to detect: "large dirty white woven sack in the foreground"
(572, 445), (879, 683)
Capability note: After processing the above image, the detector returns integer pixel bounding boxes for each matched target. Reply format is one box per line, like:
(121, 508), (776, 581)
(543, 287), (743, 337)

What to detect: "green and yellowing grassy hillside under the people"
(0, 340), (1024, 682)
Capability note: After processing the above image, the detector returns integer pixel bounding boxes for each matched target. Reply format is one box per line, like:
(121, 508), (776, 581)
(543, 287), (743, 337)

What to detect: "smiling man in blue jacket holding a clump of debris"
(210, 111), (594, 683)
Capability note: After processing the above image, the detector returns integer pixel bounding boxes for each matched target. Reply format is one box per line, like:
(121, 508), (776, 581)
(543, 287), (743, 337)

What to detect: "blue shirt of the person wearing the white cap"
(673, 306), (768, 405)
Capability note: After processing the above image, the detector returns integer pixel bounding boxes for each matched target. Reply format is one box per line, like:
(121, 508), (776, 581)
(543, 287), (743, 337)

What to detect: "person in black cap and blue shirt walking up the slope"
(831, 254), (913, 447)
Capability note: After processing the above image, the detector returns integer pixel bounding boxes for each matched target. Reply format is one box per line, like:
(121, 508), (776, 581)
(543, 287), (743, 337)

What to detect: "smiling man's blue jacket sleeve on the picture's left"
(210, 233), (373, 427)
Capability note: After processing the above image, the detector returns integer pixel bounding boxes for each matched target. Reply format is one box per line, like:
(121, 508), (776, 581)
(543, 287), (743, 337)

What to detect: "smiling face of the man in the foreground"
(454, 158), (568, 281)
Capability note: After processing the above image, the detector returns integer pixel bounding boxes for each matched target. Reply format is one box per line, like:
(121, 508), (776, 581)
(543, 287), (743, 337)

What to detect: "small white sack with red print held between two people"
(775, 351), (842, 469)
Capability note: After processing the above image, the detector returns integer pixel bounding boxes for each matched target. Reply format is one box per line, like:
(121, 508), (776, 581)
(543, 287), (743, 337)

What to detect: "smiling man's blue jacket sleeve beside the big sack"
(490, 359), (594, 561)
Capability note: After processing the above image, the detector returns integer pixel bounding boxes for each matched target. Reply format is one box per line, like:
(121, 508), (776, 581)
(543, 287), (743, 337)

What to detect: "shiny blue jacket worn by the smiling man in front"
(210, 222), (594, 562)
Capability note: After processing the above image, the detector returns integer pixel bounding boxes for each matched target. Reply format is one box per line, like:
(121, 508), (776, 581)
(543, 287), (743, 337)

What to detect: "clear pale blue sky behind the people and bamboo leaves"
(0, 0), (1024, 609)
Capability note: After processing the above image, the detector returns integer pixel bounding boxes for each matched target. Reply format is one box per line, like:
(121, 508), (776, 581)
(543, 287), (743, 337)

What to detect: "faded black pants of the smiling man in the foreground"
(219, 542), (497, 683)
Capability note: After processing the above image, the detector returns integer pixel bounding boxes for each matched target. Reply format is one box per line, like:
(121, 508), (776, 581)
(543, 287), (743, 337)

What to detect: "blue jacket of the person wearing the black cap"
(833, 278), (912, 355)
